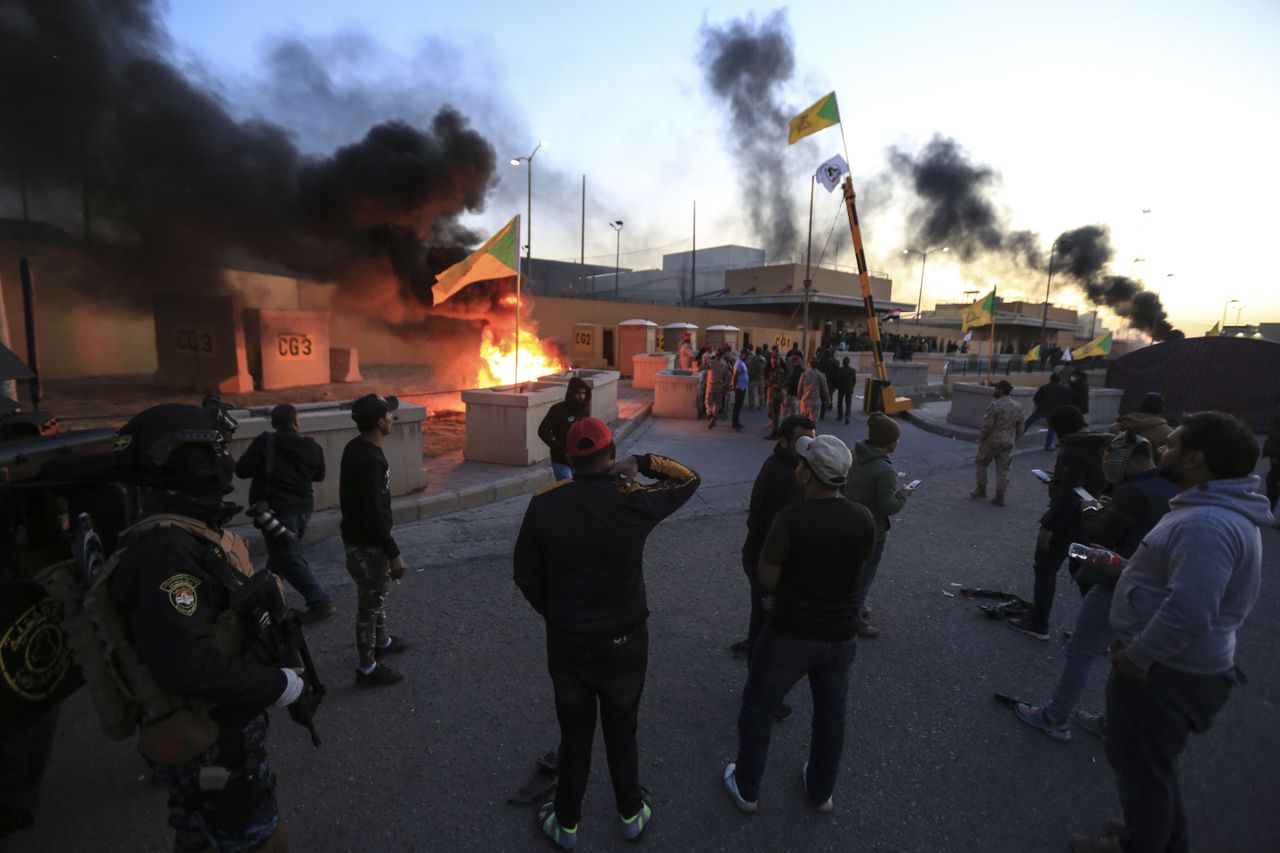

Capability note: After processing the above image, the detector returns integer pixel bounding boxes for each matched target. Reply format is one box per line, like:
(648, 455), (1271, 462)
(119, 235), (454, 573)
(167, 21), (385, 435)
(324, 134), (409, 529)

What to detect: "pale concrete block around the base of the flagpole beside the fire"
(462, 374), (563, 465)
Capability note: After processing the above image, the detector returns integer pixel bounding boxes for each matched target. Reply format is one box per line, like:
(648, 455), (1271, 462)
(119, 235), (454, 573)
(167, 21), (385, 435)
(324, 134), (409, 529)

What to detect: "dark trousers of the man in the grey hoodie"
(1107, 663), (1236, 853)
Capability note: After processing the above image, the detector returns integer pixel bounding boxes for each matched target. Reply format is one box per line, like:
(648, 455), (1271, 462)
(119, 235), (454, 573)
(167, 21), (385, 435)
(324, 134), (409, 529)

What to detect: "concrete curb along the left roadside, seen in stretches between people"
(240, 403), (653, 556)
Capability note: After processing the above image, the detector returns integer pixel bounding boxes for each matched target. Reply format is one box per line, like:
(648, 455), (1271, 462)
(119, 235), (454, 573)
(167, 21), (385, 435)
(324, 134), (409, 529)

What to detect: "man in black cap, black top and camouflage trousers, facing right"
(338, 394), (408, 686)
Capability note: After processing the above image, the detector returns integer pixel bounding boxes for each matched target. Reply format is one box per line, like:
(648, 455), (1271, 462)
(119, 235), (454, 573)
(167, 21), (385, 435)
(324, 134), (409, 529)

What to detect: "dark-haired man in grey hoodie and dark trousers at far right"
(1071, 412), (1272, 850)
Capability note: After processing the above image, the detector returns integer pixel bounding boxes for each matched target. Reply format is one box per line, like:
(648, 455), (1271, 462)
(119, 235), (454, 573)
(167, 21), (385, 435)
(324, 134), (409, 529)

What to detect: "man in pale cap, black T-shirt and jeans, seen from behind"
(723, 435), (876, 812)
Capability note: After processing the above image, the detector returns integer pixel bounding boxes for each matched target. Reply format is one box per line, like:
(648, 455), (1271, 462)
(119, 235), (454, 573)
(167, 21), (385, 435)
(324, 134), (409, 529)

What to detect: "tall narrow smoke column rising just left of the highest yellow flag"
(699, 10), (800, 257)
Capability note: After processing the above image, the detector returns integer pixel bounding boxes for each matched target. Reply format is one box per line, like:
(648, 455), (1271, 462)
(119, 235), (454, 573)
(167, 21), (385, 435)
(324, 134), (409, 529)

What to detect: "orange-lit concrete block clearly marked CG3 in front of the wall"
(244, 309), (329, 391)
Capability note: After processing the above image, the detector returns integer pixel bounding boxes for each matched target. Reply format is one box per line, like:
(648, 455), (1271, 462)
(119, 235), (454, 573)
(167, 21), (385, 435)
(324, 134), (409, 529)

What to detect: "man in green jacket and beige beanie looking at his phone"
(845, 411), (911, 639)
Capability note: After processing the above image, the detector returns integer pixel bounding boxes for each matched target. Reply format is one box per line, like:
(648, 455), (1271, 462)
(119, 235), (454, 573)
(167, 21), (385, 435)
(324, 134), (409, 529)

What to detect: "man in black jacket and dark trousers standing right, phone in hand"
(1007, 406), (1110, 640)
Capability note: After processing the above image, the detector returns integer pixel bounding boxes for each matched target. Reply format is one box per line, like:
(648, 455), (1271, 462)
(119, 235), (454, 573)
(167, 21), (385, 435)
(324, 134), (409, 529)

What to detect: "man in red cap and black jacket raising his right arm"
(513, 418), (699, 850)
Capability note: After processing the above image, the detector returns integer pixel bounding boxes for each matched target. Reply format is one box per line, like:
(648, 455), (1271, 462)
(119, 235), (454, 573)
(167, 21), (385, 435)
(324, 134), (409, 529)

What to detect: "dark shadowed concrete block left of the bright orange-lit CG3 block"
(154, 293), (253, 393)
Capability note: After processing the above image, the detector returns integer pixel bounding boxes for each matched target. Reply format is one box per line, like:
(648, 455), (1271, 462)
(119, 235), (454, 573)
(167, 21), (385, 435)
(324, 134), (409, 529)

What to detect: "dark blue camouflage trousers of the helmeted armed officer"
(147, 713), (283, 853)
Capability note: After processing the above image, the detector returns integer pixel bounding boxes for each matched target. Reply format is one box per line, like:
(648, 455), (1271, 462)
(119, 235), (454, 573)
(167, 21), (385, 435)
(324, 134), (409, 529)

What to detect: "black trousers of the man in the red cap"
(547, 624), (649, 826)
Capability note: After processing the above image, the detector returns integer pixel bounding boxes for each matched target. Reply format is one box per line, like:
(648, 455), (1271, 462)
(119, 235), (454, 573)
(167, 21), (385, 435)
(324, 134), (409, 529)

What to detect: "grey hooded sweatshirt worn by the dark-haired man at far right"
(1111, 475), (1272, 675)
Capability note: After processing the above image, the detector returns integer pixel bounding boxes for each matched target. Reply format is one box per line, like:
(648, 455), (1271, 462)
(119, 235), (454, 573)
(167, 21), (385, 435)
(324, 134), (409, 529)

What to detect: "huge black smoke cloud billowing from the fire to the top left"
(0, 0), (495, 318)
